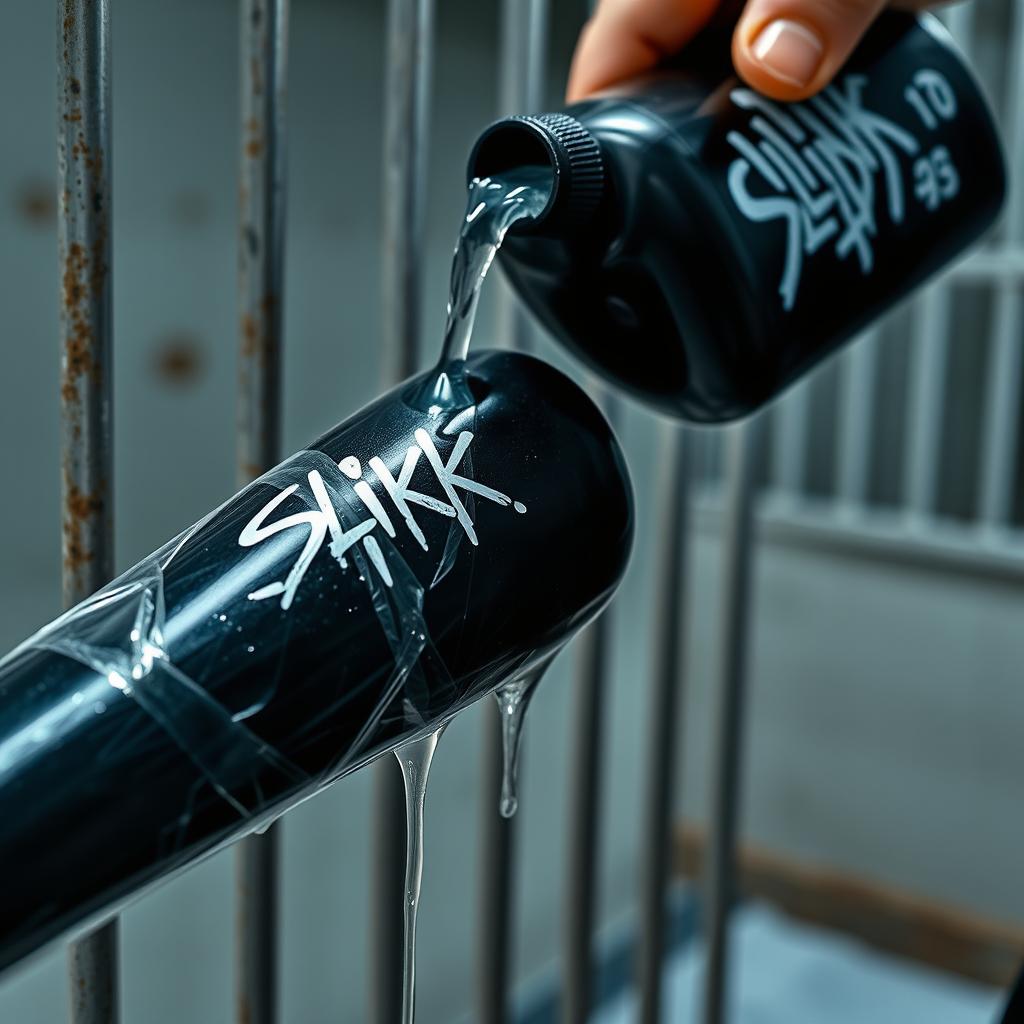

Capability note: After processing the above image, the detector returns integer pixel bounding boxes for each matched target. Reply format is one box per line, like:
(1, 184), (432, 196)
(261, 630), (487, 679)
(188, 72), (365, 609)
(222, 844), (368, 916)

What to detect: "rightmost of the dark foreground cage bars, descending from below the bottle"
(703, 418), (762, 1024)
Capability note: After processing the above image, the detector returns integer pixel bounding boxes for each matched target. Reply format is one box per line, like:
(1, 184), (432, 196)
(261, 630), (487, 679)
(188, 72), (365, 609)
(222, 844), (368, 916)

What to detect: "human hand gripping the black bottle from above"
(567, 0), (942, 102)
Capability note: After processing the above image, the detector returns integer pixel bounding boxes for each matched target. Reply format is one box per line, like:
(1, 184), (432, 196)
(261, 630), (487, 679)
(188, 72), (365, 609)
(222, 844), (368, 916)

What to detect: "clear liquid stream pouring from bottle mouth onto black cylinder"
(415, 167), (554, 416)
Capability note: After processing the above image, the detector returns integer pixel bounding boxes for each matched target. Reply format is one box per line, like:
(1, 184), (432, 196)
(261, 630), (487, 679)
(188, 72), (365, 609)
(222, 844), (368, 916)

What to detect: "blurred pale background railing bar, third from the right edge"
(836, 330), (879, 513)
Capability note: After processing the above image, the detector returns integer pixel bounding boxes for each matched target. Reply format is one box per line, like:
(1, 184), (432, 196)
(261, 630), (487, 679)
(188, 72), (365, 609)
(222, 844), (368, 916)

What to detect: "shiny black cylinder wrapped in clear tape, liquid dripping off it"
(0, 352), (633, 967)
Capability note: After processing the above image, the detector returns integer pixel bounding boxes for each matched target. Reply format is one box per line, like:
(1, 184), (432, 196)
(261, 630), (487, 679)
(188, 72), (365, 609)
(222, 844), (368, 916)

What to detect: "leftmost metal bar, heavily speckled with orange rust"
(57, 0), (120, 1024)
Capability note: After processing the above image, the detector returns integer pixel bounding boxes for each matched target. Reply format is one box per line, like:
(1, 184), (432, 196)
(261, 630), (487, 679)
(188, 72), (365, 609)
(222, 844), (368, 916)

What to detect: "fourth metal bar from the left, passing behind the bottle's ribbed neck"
(476, 0), (548, 1024)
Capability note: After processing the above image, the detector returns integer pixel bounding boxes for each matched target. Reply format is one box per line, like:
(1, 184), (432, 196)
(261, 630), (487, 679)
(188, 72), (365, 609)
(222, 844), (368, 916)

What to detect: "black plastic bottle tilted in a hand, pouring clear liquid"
(469, 12), (1006, 422)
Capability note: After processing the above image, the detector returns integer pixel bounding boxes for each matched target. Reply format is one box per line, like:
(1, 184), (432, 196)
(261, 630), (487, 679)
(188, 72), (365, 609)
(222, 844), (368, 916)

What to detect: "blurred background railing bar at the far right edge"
(978, 3), (1024, 530)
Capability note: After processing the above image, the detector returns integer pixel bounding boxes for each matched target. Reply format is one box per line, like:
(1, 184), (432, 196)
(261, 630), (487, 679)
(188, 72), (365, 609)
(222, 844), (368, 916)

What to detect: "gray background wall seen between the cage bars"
(0, 0), (1024, 1024)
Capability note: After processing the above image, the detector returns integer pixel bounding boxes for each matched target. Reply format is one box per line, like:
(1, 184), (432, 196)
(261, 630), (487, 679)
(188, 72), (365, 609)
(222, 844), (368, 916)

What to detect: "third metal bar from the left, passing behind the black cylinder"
(370, 0), (434, 1024)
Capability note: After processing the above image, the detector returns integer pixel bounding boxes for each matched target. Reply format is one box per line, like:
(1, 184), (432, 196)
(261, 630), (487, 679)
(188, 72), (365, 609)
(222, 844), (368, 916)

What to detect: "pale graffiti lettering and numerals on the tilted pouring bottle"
(726, 69), (959, 310)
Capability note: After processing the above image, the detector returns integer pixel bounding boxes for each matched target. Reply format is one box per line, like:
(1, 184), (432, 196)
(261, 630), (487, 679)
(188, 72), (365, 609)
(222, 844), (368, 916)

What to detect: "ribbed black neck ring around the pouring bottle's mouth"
(467, 114), (604, 233)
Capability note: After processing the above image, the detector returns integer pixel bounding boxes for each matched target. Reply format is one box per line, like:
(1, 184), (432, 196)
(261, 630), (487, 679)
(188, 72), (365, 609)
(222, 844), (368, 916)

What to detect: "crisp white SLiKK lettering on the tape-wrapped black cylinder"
(239, 429), (526, 608)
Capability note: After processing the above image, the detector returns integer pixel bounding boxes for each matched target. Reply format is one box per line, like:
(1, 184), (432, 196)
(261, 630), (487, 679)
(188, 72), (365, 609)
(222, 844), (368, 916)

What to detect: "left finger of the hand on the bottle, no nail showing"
(566, 0), (719, 103)
